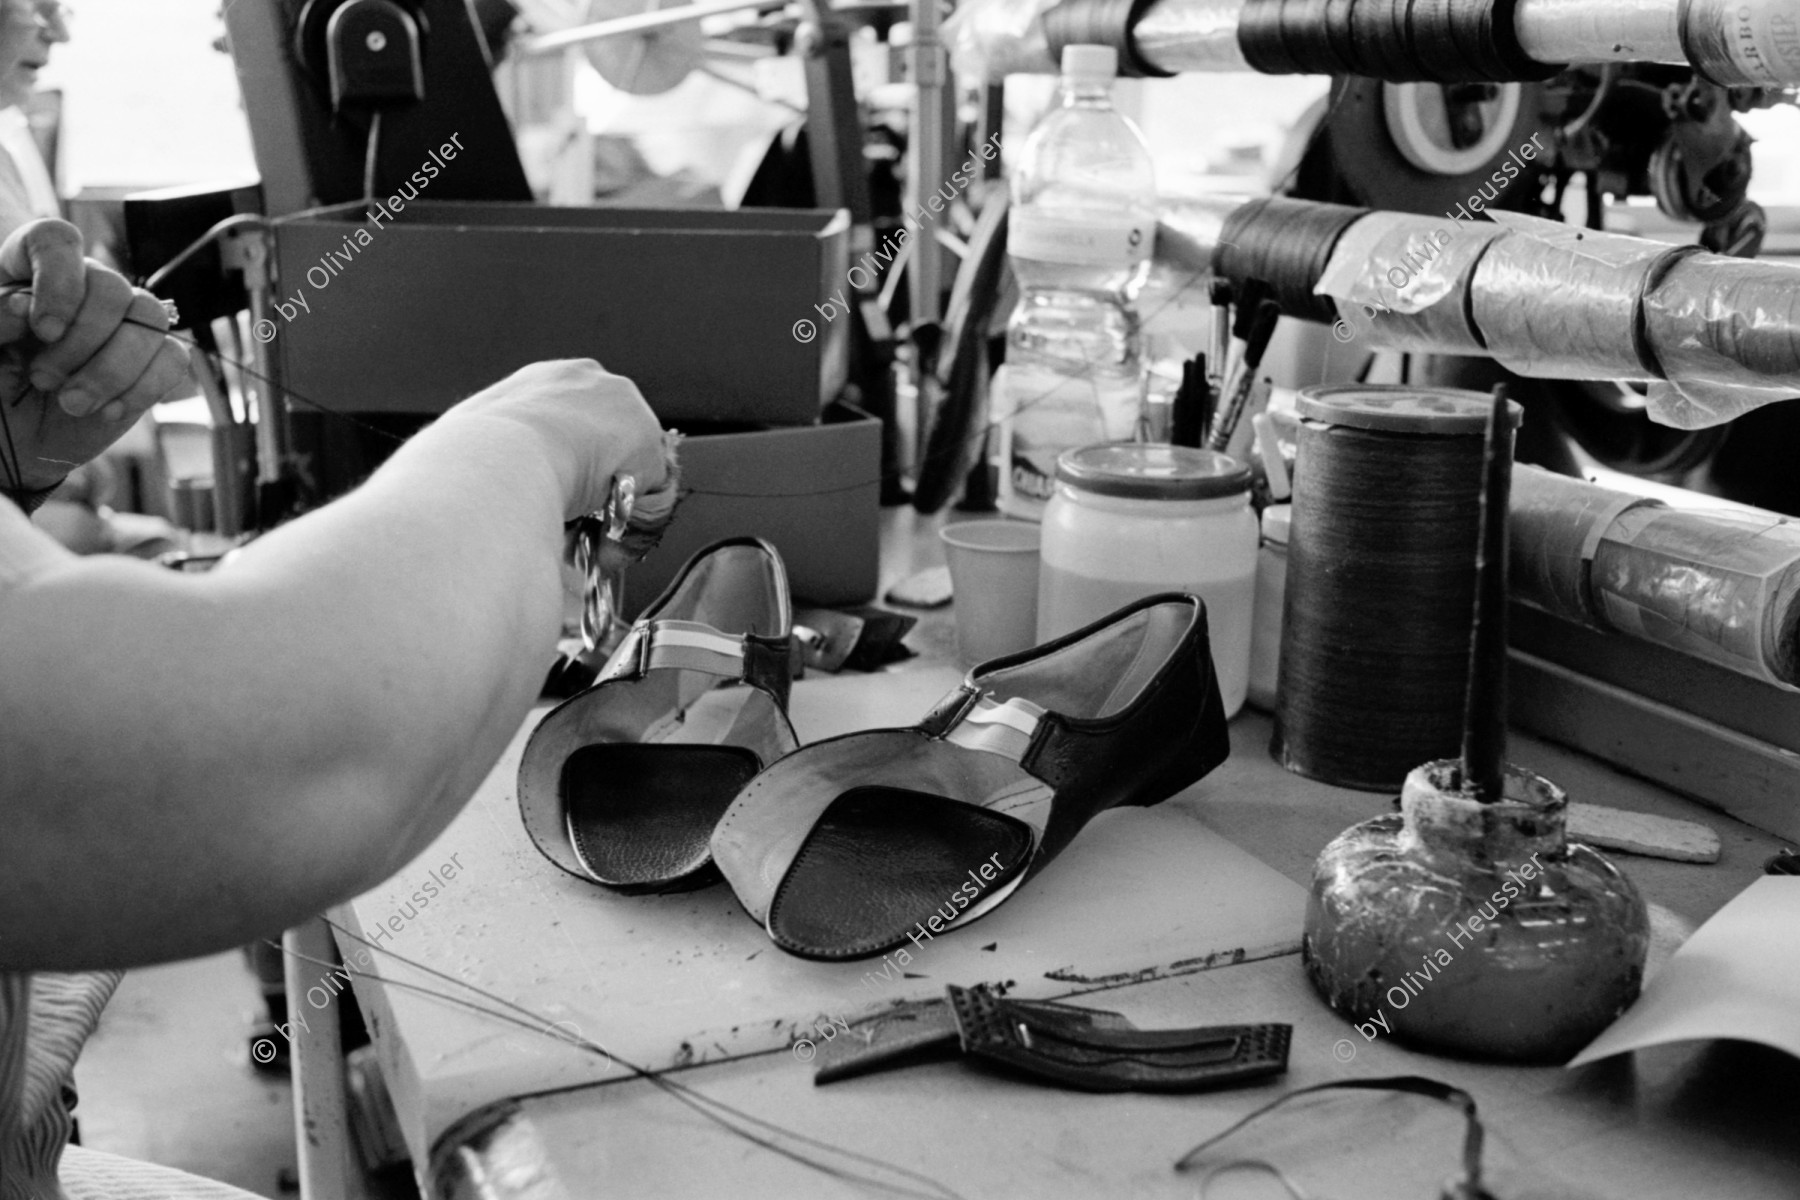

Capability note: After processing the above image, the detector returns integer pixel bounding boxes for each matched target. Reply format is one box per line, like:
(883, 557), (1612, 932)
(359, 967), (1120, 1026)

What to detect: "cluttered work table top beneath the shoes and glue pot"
(313, 509), (1800, 1200)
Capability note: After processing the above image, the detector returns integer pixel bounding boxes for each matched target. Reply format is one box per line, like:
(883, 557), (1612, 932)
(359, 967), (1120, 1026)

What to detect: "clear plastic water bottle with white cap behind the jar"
(992, 45), (1156, 520)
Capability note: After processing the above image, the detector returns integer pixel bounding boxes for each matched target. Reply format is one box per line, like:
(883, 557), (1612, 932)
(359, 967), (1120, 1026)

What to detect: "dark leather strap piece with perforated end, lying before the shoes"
(949, 986), (1292, 1092)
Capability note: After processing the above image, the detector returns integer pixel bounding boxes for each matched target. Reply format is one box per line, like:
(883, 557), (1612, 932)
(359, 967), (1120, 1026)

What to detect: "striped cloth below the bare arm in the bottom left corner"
(0, 972), (119, 1200)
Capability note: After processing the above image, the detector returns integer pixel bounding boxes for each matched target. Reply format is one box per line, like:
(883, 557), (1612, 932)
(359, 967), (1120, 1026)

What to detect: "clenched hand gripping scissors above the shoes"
(445, 358), (668, 520)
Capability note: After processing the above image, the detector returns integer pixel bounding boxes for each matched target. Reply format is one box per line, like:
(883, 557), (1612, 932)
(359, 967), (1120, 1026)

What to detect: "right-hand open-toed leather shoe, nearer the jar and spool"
(713, 594), (1229, 959)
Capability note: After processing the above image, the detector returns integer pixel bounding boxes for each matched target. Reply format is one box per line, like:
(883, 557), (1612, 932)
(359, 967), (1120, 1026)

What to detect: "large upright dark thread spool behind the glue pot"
(1271, 385), (1521, 792)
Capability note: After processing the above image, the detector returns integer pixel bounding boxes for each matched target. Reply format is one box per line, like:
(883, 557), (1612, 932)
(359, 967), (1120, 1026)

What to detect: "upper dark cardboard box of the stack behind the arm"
(271, 200), (850, 425)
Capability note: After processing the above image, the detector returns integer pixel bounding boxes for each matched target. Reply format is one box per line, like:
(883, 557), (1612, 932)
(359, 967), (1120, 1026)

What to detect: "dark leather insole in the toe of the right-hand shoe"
(769, 788), (1031, 959)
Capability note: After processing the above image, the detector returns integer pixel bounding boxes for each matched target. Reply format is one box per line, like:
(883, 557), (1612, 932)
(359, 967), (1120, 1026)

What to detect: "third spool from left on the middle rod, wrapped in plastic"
(1472, 214), (1694, 380)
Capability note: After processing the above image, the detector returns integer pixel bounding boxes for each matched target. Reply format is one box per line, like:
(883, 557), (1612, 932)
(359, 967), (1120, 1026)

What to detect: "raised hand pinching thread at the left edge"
(0, 219), (191, 491)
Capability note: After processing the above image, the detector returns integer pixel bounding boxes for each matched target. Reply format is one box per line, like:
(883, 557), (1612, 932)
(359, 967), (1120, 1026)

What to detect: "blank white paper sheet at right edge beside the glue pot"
(1570, 874), (1800, 1067)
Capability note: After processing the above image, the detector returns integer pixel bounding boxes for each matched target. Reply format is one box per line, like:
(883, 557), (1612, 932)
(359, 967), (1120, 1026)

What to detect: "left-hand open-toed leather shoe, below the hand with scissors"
(518, 538), (797, 892)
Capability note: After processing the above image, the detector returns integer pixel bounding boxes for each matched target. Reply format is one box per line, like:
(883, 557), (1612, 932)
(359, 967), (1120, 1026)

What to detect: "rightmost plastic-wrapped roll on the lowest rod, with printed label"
(1591, 507), (1800, 685)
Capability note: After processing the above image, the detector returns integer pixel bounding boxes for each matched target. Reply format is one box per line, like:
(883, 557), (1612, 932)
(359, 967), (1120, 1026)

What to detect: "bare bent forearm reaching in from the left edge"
(0, 363), (653, 968)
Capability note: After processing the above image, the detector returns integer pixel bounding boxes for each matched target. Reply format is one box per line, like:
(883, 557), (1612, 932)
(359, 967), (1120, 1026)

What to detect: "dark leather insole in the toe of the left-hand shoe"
(562, 743), (761, 889)
